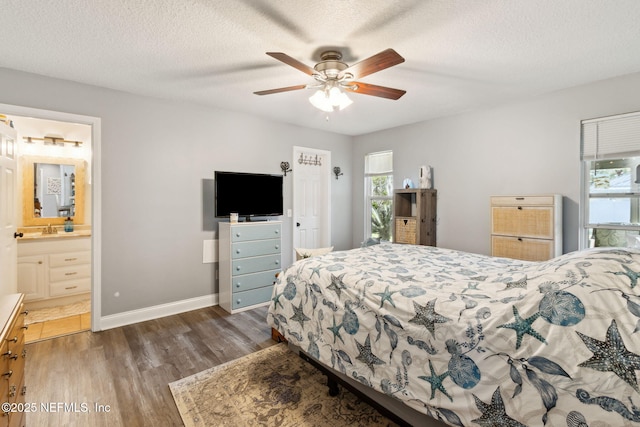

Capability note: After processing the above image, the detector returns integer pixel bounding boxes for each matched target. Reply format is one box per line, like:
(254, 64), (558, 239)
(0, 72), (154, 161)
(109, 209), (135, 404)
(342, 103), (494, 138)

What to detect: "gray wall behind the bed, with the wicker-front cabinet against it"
(352, 74), (640, 254)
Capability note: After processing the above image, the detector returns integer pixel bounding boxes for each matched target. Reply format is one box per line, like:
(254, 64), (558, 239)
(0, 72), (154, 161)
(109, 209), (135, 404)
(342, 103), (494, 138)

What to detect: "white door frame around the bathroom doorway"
(0, 104), (102, 332)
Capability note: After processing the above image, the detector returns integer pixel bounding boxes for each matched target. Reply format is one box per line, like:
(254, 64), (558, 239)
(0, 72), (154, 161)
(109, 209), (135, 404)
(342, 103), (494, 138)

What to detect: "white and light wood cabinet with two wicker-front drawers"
(491, 194), (562, 261)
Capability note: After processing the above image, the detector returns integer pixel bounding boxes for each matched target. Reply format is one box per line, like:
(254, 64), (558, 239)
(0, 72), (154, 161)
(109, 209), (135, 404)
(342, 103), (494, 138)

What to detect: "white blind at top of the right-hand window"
(581, 112), (640, 160)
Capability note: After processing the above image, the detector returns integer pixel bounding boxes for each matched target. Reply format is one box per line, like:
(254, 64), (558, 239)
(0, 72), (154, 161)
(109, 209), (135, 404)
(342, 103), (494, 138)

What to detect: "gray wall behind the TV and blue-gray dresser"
(0, 69), (351, 316)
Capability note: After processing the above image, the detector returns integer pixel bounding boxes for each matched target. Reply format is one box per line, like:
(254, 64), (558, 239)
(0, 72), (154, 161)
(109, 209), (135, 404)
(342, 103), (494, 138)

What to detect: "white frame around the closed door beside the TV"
(291, 146), (331, 260)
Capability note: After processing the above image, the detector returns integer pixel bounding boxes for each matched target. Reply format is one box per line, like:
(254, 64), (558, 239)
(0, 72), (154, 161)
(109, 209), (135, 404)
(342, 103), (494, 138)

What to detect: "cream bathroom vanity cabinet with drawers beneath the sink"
(18, 237), (91, 301)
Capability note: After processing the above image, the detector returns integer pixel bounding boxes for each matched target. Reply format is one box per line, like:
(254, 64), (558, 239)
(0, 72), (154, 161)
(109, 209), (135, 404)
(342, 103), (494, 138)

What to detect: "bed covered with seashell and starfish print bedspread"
(268, 244), (640, 427)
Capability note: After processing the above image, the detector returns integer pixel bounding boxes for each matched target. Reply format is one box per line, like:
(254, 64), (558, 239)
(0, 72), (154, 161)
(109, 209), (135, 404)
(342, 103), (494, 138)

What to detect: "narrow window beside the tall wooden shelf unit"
(364, 151), (393, 241)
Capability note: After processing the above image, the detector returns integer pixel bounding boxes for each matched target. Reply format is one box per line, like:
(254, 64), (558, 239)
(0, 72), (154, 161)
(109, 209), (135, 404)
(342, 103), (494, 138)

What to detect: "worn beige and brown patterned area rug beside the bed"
(169, 344), (396, 427)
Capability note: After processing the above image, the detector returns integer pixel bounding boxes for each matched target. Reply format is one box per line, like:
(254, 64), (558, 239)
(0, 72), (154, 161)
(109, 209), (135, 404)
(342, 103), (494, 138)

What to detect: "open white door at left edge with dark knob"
(0, 123), (18, 295)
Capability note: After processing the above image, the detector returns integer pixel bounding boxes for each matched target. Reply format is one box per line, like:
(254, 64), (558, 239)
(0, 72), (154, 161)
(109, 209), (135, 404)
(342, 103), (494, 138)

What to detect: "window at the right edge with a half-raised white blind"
(580, 113), (640, 248)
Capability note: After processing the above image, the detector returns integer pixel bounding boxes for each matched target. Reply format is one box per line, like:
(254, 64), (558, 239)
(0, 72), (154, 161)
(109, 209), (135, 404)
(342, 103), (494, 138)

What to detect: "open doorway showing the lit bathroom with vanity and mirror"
(3, 106), (99, 342)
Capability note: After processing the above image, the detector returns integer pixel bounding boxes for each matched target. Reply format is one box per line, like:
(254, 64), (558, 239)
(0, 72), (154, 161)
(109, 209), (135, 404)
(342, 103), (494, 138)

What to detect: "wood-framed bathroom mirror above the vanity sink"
(22, 156), (85, 226)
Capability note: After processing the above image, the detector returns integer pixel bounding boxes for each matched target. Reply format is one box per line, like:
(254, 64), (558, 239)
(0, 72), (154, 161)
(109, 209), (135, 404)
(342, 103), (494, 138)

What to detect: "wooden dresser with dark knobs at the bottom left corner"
(0, 294), (27, 427)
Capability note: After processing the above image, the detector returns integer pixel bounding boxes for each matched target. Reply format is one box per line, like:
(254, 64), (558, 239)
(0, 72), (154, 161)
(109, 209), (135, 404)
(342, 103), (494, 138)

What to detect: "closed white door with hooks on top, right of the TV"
(293, 147), (331, 254)
